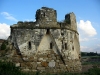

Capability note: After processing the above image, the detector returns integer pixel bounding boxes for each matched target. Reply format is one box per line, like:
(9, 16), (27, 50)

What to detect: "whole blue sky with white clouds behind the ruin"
(0, 0), (100, 53)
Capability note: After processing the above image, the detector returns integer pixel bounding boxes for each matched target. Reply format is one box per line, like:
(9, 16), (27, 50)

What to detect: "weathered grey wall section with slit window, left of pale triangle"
(11, 29), (45, 56)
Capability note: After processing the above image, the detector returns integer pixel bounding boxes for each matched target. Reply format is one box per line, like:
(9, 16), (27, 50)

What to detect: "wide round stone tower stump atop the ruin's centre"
(36, 7), (57, 27)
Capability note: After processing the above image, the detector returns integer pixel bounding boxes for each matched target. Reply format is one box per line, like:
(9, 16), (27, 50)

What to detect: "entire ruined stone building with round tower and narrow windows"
(8, 7), (81, 72)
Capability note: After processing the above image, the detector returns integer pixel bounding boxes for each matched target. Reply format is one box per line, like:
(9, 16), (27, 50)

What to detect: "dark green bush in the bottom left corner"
(0, 61), (27, 75)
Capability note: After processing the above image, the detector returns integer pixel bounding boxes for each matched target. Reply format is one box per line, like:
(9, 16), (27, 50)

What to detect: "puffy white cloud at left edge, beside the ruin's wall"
(0, 23), (10, 39)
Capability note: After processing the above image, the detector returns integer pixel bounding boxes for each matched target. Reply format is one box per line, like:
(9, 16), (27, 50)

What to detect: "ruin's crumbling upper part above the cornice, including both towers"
(11, 7), (77, 32)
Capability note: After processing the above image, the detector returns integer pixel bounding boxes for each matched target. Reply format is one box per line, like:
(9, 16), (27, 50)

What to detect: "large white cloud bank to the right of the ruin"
(77, 20), (100, 53)
